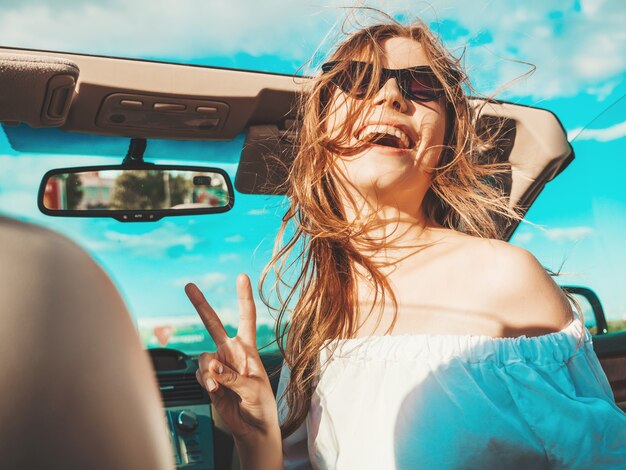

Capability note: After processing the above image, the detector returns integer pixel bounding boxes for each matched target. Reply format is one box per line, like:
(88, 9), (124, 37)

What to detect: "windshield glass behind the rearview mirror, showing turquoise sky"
(0, 126), (285, 353)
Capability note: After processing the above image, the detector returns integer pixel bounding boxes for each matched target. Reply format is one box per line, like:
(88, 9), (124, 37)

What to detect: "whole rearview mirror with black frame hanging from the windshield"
(37, 163), (235, 222)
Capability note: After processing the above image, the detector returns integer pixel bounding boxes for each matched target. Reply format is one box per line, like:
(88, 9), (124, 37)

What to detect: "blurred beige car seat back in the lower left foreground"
(0, 217), (175, 470)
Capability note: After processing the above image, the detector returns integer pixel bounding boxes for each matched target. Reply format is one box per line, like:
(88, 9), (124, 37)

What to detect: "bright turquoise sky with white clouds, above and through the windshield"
(0, 0), (626, 338)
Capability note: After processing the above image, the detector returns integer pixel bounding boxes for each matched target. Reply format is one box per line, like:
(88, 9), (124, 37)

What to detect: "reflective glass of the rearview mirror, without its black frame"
(43, 169), (229, 211)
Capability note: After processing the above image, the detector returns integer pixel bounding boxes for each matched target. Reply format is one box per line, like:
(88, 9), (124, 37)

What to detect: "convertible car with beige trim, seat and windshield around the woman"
(0, 48), (626, 470)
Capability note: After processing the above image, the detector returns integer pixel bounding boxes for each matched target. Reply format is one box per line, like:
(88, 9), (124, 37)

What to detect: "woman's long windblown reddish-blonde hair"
(259, 15), (582, 438)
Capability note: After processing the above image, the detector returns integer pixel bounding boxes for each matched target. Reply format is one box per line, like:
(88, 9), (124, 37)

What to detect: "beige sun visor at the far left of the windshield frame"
(0, 53), (79, 127)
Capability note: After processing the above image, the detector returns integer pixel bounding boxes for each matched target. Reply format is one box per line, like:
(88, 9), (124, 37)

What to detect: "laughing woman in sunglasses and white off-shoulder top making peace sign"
(186, 16), (626, 469)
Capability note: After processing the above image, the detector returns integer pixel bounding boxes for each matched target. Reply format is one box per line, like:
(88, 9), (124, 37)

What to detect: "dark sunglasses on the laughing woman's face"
(322, 60), (445, 103)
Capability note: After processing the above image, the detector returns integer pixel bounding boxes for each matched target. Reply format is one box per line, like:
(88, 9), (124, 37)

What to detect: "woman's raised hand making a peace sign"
(185, 274), (279, 440)
